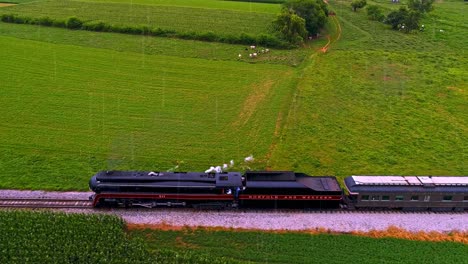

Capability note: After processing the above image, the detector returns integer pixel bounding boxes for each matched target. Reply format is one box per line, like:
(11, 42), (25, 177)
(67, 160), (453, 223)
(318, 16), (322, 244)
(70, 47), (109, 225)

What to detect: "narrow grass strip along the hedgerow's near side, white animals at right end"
(0, 23), (310, 66)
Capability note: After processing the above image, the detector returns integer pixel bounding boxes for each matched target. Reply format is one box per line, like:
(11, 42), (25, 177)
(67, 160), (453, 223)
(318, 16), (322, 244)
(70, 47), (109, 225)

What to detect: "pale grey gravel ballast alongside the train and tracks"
(0, 190), (468, 232)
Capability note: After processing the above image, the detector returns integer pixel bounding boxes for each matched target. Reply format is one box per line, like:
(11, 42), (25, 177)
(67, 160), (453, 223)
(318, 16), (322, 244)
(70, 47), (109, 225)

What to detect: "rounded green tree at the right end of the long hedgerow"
(273, 11), (307, 45)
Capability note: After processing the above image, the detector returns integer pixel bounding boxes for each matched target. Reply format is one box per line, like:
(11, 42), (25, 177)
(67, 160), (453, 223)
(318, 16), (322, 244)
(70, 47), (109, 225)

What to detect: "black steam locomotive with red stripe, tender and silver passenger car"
(89, 171), (468, 211)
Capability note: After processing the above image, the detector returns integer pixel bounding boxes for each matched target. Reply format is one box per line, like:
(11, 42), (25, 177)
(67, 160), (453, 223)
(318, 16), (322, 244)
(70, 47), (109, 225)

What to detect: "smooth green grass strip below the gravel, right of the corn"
(130, 230), (468, 264)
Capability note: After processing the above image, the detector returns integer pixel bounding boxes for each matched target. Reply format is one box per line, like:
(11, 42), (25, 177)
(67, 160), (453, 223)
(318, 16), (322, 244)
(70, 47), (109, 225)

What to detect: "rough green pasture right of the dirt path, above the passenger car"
(270, 1), (468, 175)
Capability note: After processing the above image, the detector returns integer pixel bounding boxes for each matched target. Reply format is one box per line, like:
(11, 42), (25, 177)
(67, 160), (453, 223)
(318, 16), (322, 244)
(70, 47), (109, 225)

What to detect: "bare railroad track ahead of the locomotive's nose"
(0, 198), (92, 208)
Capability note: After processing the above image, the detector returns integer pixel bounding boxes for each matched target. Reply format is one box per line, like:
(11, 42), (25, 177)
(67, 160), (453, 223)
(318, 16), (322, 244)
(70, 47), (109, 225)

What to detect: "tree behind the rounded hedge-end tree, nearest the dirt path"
(283, 0), (328, 35)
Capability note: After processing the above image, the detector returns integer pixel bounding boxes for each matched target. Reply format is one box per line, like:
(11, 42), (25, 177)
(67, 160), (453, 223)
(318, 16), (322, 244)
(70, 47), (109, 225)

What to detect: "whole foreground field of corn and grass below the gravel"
(0, 210), (468, 264)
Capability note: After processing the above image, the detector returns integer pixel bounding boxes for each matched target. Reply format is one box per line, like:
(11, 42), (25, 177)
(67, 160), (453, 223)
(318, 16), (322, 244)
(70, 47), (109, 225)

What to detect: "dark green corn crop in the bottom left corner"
(0, 210), (239, 264)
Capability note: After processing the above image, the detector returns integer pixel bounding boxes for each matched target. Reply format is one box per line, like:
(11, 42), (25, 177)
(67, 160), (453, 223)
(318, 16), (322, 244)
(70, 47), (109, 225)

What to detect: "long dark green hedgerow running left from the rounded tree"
(0, 14), (289, 48)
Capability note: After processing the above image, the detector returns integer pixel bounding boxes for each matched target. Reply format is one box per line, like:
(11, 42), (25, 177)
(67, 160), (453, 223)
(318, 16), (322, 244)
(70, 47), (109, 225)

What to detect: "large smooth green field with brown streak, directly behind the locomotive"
(0, 37), (293, 190)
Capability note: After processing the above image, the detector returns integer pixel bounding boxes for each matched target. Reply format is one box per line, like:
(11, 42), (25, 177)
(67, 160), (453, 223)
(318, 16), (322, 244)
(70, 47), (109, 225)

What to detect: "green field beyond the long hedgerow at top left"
(0, 0), (275, 36)
